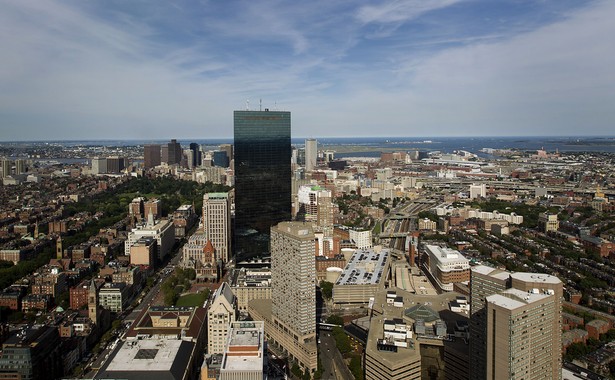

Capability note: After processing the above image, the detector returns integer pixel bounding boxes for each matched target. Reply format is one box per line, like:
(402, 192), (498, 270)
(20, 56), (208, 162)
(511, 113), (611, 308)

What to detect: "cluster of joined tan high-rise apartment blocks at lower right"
(470, 265), (563, 379)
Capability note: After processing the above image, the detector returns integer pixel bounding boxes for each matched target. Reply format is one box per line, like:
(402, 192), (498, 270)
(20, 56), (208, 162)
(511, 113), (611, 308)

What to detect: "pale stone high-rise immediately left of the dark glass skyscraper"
(203, 193), (231, 263)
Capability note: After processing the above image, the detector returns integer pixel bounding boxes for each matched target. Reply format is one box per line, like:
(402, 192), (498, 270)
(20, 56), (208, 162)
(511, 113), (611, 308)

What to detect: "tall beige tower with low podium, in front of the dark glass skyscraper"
(248, 222), (317, 373)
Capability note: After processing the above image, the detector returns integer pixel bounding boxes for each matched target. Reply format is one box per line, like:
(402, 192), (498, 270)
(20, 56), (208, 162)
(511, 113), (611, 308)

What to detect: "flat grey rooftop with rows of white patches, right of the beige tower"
(336, 249), (390, 285)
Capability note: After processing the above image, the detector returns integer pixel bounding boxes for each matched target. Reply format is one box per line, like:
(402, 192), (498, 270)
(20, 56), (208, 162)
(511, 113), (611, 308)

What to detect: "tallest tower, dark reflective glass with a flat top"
(234, 109), (291, 258)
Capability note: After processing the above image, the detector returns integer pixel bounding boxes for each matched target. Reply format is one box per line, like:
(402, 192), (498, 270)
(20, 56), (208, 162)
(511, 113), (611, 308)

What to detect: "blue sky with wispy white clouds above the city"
(0, 0), (615, 141)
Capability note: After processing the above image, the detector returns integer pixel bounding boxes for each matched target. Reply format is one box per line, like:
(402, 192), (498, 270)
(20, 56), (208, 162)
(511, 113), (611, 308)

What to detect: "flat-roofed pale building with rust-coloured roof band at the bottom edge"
(220, 321), (266, 380)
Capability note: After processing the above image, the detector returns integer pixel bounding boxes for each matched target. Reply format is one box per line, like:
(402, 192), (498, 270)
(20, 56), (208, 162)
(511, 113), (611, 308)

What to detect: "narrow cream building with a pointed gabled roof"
(207, 282), (237, 355)
